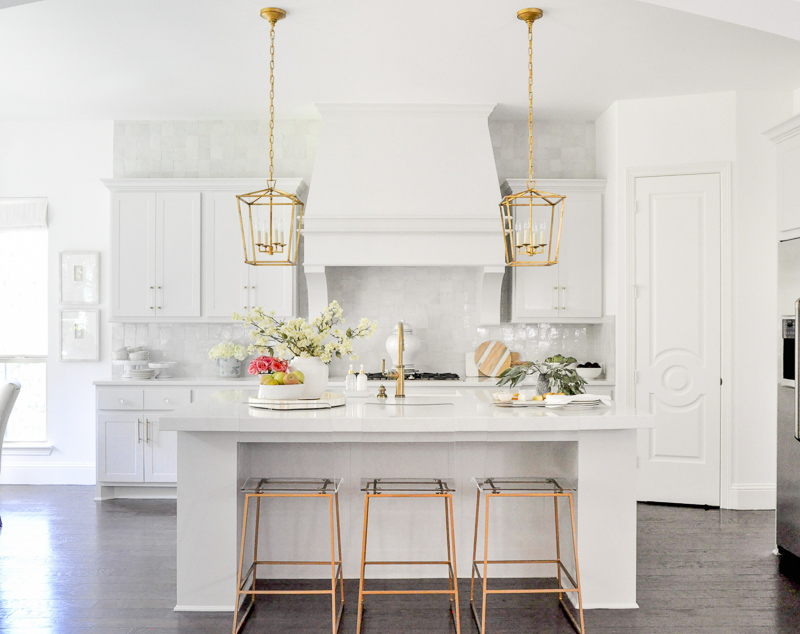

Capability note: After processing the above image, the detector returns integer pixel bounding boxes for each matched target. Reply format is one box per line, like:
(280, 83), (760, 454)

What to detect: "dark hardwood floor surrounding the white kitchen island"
(0, 486), (800, 634)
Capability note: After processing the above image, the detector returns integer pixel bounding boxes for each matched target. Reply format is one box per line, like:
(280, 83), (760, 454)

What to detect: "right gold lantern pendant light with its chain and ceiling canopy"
(500, 9), (566, 266)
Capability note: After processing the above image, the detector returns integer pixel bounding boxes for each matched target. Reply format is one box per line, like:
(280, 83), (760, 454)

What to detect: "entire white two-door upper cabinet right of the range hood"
(504, 179), (605, 323)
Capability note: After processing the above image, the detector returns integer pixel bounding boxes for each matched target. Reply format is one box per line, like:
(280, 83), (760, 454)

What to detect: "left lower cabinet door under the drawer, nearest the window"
(97, 411), (144, 482)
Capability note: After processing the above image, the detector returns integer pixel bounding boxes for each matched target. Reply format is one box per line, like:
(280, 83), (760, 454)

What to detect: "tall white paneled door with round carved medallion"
(635, 174), (721, 506)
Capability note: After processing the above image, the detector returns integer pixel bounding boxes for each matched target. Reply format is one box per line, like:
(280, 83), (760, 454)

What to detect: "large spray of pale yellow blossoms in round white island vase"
(233, 300), (378, 363)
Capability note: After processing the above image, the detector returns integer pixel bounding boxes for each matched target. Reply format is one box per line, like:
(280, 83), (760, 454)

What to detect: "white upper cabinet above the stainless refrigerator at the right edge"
(765, 115), (800, 240)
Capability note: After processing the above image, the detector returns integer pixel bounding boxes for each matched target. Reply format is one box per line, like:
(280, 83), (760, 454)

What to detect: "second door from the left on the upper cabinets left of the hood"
(155, 192), (201, 317)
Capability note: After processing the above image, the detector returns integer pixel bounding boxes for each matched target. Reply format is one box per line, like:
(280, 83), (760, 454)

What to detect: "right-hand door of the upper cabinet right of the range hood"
(558, 192), (603, 317)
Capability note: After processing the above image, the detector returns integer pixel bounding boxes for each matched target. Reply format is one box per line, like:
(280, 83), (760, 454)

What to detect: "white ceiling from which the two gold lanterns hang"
(0, 0), (800, 120)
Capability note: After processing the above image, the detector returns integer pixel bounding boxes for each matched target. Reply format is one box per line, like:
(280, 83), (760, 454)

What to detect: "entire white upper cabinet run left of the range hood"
(104, 178), (305, 322)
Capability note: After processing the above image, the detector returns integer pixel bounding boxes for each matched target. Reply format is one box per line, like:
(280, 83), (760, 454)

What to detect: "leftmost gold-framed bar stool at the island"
(233, 478), (344, 634)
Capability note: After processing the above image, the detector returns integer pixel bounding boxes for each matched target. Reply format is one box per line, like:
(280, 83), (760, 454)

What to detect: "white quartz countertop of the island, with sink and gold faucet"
(159, 388), (653, 435)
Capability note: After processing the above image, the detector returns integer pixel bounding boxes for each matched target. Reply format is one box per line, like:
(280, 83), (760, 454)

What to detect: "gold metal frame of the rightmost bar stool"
(469, 478), (586, 634)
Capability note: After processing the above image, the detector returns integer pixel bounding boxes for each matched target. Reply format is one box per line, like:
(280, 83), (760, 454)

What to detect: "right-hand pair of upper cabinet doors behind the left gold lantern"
(203, 190), (295, 319)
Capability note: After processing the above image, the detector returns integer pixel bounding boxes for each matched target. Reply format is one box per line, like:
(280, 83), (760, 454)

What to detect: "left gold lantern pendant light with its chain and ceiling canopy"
(236, 7), (304, 266)
